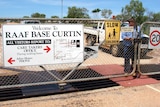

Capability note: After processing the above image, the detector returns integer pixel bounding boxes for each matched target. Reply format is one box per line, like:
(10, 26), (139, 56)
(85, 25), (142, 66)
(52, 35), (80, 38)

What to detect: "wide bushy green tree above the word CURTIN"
(67, 6), (89, 18)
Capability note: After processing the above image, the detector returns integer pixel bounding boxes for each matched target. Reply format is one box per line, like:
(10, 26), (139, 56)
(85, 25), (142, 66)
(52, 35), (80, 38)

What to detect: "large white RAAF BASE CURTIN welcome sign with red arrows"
(3, 24), (84, 66)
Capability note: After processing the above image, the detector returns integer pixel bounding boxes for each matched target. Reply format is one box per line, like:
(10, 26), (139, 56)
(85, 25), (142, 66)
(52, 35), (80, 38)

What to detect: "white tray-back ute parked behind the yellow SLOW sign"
(84, 22), (149, 56)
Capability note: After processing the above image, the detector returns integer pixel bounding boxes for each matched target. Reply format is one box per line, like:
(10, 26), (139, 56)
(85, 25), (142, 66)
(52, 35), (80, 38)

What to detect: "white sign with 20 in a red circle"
(148, 27), (160, 49)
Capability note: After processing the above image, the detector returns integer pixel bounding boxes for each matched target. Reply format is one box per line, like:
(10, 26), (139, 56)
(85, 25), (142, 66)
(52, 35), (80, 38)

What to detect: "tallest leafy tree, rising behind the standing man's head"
(121, 0), (145, 24)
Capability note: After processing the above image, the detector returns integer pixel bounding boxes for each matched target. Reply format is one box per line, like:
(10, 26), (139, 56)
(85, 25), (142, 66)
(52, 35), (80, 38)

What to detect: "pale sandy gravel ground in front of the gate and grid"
(0, 84), (160, 107)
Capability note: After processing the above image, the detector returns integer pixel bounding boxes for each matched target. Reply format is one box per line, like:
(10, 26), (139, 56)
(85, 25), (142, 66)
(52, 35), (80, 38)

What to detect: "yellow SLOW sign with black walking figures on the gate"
(105, 20), (120, 45)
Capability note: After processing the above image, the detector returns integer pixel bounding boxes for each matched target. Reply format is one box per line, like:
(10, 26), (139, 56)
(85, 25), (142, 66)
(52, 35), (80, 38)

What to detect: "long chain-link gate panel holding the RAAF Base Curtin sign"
(0, 19), (138, 93)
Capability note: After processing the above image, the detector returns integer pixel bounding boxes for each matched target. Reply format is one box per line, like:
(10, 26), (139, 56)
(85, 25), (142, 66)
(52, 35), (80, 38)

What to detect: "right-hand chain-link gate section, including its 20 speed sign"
(138, 22), (160, 75)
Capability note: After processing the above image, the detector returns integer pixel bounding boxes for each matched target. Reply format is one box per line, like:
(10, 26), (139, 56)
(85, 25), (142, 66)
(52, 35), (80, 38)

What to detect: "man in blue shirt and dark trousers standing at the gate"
(122, 18), (136, 74)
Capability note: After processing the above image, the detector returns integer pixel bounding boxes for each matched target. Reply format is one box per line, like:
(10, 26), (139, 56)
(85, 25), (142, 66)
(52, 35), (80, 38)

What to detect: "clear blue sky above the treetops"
(0, 0), (160, 18)
